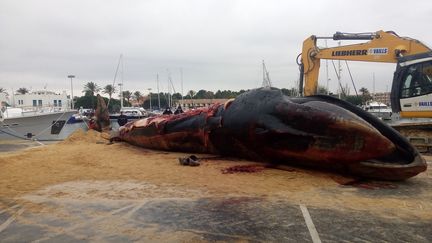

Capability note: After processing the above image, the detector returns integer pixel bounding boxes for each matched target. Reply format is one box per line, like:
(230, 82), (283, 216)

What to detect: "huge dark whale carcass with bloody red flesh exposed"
(108, 88), (426, 180)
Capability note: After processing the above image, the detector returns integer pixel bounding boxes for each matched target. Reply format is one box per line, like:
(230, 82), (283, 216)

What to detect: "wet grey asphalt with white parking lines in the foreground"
(0, 183), (432, 242)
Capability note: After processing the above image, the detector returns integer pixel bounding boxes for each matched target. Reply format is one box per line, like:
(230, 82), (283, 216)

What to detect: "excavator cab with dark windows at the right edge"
(391, 52), (432, 117)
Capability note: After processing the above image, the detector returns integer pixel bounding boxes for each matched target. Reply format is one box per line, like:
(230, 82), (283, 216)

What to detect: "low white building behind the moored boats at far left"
(10, 90), (71, 109)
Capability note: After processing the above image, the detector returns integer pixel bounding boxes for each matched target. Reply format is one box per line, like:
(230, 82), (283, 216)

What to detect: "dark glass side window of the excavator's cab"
(401, 62), (432, 98)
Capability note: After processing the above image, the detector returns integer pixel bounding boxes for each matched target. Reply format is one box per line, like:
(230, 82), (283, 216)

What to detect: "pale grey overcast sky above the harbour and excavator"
(0, 0), (432, 98)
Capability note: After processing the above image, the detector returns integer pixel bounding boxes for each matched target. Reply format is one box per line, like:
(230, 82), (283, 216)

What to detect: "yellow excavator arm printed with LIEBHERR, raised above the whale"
(300, 30), (431, 96)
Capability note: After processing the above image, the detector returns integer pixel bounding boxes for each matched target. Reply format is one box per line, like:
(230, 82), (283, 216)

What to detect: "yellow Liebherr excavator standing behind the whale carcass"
(299, 30), (432, 152)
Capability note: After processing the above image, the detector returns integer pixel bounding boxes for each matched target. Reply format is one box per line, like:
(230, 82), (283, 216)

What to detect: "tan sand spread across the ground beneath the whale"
(0, 130), (432, 219)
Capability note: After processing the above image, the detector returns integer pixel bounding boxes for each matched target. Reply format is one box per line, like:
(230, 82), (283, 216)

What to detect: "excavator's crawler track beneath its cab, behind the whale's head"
(391, 122), (432, 153)
